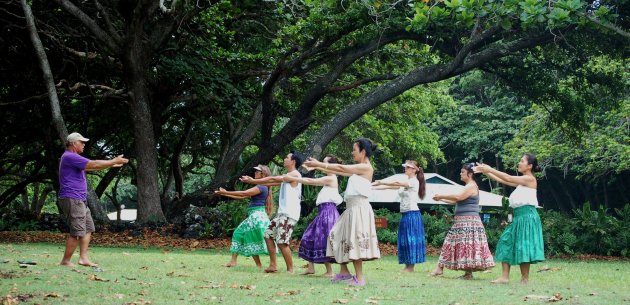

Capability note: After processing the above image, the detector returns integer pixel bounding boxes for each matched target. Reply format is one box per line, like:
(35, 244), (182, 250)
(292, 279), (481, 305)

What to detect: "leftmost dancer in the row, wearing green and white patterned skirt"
(215, 165), (273, 268)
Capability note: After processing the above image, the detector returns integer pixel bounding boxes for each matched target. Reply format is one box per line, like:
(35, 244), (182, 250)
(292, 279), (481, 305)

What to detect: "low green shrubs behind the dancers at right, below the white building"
(375, 203), (630, 257)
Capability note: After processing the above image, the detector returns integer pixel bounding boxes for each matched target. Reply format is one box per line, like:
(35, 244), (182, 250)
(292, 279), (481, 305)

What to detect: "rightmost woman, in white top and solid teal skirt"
(474, 154), (545, 284)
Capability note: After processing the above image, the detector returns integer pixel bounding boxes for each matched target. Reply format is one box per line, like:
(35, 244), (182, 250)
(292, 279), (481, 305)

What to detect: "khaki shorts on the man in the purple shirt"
(59, 198), (95, 237)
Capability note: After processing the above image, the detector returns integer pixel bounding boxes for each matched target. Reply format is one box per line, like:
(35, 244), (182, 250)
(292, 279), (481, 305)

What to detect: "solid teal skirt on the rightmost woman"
(494, 205), (545, 265)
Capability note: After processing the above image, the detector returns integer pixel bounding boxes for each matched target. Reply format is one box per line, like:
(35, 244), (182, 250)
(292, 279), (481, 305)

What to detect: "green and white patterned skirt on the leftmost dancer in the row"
(230, 206), (269, 256)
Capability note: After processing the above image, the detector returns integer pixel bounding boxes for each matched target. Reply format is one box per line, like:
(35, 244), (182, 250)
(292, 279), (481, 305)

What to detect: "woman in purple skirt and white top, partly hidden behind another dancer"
(284, 155), (343, 277)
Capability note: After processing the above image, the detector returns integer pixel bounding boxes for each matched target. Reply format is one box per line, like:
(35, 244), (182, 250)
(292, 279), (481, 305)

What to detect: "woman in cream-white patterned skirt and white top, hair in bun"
(304, 139), (381, 286)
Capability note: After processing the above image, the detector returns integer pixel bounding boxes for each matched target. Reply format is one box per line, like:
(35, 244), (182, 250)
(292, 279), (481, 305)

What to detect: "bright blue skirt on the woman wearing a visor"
(398, 211), (426, 265)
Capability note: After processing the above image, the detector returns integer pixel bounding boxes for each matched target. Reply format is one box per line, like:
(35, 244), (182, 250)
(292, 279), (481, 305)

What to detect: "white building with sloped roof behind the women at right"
(369, 173), (504, 210)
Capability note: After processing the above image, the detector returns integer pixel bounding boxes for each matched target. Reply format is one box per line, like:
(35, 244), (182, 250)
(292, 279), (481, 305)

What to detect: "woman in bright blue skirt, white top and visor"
(372, 160), (426, 272)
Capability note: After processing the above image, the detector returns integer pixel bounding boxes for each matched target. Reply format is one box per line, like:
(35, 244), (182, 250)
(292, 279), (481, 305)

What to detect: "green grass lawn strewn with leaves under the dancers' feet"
(0, 243), (630, 304)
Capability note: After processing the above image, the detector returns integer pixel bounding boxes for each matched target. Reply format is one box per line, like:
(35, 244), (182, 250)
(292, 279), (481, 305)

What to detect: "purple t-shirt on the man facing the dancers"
(59, 150), (90, 201)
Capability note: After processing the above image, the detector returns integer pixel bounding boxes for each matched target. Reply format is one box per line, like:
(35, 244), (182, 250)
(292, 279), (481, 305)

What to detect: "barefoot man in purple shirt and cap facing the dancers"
(59, 132), (129, 267)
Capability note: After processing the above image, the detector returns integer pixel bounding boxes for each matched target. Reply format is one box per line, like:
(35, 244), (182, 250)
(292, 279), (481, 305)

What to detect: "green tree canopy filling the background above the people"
(0, 0), (630, 223)
